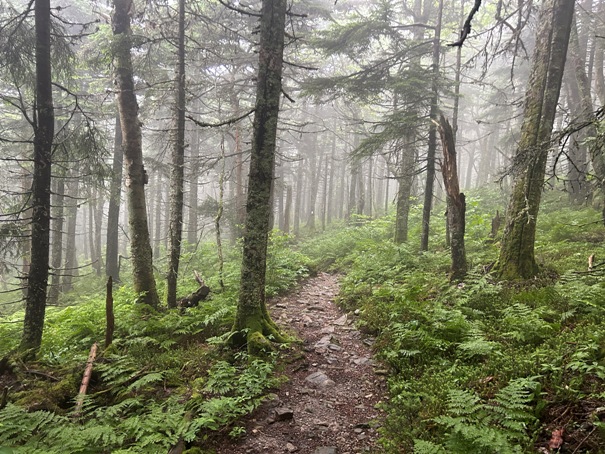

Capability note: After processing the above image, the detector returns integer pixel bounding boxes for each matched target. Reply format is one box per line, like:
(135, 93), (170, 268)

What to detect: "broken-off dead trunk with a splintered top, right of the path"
(439, 115), (467, 281)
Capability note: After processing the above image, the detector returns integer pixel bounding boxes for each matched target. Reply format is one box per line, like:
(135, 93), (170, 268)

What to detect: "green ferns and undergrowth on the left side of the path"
(0, 235), (309, 454)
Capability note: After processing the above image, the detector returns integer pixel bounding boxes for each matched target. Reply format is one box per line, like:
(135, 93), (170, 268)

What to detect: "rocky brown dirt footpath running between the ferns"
(217, 273), (386, 454)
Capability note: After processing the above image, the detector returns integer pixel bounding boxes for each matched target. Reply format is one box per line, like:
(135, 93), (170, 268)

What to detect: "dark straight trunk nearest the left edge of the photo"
(20, 0), (55, 357)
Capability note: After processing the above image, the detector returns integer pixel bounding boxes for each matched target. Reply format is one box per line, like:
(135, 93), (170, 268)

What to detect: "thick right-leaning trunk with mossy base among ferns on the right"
(495, 0), (574, 279)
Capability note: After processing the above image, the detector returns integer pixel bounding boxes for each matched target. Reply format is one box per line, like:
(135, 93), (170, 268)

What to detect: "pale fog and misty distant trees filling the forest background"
(0, 0), (605, 347)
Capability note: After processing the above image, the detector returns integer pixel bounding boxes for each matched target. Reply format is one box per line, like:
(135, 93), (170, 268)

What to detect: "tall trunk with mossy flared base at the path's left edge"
(232, 0), (287, 354)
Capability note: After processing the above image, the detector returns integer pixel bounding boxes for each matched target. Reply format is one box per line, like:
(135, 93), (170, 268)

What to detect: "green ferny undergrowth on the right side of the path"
(307, 190), (605, 453)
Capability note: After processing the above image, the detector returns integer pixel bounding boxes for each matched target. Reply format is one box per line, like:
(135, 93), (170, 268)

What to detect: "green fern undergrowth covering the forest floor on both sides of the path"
(0, 187), (605, 453)
